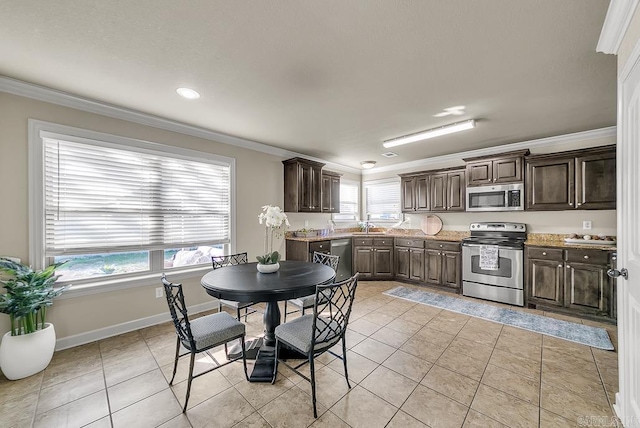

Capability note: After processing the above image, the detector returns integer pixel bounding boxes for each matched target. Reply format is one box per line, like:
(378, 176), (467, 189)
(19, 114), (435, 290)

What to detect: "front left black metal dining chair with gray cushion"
(162, 274), (249, 413)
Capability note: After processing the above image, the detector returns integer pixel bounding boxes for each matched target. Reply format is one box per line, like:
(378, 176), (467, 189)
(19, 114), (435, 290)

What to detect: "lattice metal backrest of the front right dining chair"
(311, 273), (358, 349)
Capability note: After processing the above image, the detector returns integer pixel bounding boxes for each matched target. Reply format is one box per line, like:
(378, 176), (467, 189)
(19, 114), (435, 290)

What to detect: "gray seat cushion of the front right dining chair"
(275, 315), (340, 354)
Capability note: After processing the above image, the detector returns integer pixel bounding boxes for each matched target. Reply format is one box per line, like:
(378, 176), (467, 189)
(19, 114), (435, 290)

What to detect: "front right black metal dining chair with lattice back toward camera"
(271, 273), (358, 418)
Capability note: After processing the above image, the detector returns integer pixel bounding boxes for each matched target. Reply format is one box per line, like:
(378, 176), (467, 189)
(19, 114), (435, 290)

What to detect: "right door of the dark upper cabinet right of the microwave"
(576, 150), (616, 210)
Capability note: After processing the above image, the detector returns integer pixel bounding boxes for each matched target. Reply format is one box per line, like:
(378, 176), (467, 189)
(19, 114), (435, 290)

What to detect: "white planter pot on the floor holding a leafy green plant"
(0, 323), (56, 380)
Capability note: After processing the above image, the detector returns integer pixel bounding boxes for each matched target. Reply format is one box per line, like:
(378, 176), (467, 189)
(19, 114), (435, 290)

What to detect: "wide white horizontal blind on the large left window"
(44, 138), (231, 257)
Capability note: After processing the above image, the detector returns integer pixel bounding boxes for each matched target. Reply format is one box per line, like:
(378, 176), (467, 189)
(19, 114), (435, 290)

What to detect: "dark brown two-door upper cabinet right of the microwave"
(525, 146), (616, 211)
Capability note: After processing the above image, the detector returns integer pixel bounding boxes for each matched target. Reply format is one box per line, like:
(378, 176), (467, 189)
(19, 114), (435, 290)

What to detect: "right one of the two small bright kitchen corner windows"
(364, 180), (400, 221)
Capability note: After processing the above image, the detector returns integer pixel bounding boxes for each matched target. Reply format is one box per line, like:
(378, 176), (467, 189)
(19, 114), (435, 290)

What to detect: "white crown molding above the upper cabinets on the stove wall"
(362, 126), (616, 176)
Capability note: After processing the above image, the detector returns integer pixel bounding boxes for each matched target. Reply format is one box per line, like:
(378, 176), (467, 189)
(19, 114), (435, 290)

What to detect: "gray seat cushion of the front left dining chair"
(183, 312), (245, 351)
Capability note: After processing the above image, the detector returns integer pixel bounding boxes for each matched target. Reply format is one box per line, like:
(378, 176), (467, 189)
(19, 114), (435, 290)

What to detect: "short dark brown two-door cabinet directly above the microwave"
(463, 149), (529, 187)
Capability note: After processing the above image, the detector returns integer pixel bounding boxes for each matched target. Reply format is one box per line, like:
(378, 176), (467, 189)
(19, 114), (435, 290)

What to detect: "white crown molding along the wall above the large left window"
(0, 76), (361, 174)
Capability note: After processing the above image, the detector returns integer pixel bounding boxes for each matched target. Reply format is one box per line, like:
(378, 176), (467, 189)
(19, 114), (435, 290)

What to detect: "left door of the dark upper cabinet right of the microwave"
(525, 157), (575, 210)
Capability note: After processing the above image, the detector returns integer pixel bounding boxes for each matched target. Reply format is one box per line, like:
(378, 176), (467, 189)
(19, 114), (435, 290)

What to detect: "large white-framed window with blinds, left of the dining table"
(31, 121), (234, 285)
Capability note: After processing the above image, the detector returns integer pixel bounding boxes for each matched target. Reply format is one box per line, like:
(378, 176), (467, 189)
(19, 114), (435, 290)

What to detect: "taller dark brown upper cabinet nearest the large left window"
(282, 158), (324, 213)
